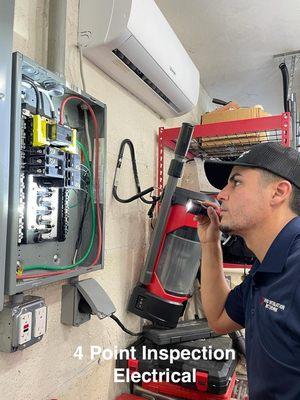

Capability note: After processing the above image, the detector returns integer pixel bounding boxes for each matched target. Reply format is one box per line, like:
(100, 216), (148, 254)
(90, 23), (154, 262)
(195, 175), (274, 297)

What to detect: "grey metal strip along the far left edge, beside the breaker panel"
(0, 0), (15, 311)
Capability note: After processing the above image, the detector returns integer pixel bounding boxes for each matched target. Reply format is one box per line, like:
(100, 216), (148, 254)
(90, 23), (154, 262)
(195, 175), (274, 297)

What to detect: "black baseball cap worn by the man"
(204, 142), (300, 189)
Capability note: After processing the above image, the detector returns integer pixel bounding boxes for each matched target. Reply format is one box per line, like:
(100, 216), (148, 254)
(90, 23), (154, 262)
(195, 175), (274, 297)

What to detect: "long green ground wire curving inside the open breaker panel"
(23, 140), (96, 271)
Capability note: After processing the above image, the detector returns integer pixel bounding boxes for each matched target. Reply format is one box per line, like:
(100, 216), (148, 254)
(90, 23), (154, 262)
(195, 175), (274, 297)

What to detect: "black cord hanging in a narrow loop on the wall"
(112, 139), (157, 204)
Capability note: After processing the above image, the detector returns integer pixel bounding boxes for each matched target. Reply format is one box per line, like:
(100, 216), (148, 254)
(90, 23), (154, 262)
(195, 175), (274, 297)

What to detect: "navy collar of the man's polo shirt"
(251, 217), (300, 275)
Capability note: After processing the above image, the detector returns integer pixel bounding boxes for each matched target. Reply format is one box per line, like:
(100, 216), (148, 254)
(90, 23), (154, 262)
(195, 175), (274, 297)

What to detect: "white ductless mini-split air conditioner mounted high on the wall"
(79, 0), (200, 118)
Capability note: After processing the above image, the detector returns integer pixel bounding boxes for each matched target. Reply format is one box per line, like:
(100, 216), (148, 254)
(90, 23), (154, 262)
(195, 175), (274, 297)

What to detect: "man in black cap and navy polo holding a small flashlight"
(195, 143), (300, 400)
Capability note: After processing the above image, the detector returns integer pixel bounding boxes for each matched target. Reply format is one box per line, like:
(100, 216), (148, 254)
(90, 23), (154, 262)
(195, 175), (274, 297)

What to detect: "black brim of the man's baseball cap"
(204, 160), (254, 189)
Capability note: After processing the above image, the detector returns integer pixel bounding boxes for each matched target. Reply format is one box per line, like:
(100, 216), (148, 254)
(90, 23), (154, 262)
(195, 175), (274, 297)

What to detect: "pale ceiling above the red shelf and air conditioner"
(155, 0), (300, 114)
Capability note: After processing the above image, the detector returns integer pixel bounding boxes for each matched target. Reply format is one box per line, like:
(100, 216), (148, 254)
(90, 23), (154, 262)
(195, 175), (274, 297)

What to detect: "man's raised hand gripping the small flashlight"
(194, 201), (221, 245)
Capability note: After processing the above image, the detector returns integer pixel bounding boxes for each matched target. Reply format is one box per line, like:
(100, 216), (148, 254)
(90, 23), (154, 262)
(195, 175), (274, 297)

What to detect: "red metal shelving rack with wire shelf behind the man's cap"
(157, 113), (291, 268)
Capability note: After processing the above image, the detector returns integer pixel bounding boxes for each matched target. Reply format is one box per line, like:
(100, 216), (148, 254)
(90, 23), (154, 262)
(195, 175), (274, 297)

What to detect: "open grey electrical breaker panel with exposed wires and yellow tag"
(2, 53), (106, 295)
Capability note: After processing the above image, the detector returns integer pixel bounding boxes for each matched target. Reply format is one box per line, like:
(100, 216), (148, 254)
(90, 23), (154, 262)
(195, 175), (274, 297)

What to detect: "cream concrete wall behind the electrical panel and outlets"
(0, 0), (218, 400)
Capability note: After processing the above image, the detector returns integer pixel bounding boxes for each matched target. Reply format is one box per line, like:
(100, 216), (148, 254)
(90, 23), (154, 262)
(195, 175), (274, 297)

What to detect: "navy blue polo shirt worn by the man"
(225, 217), (300, 400)
